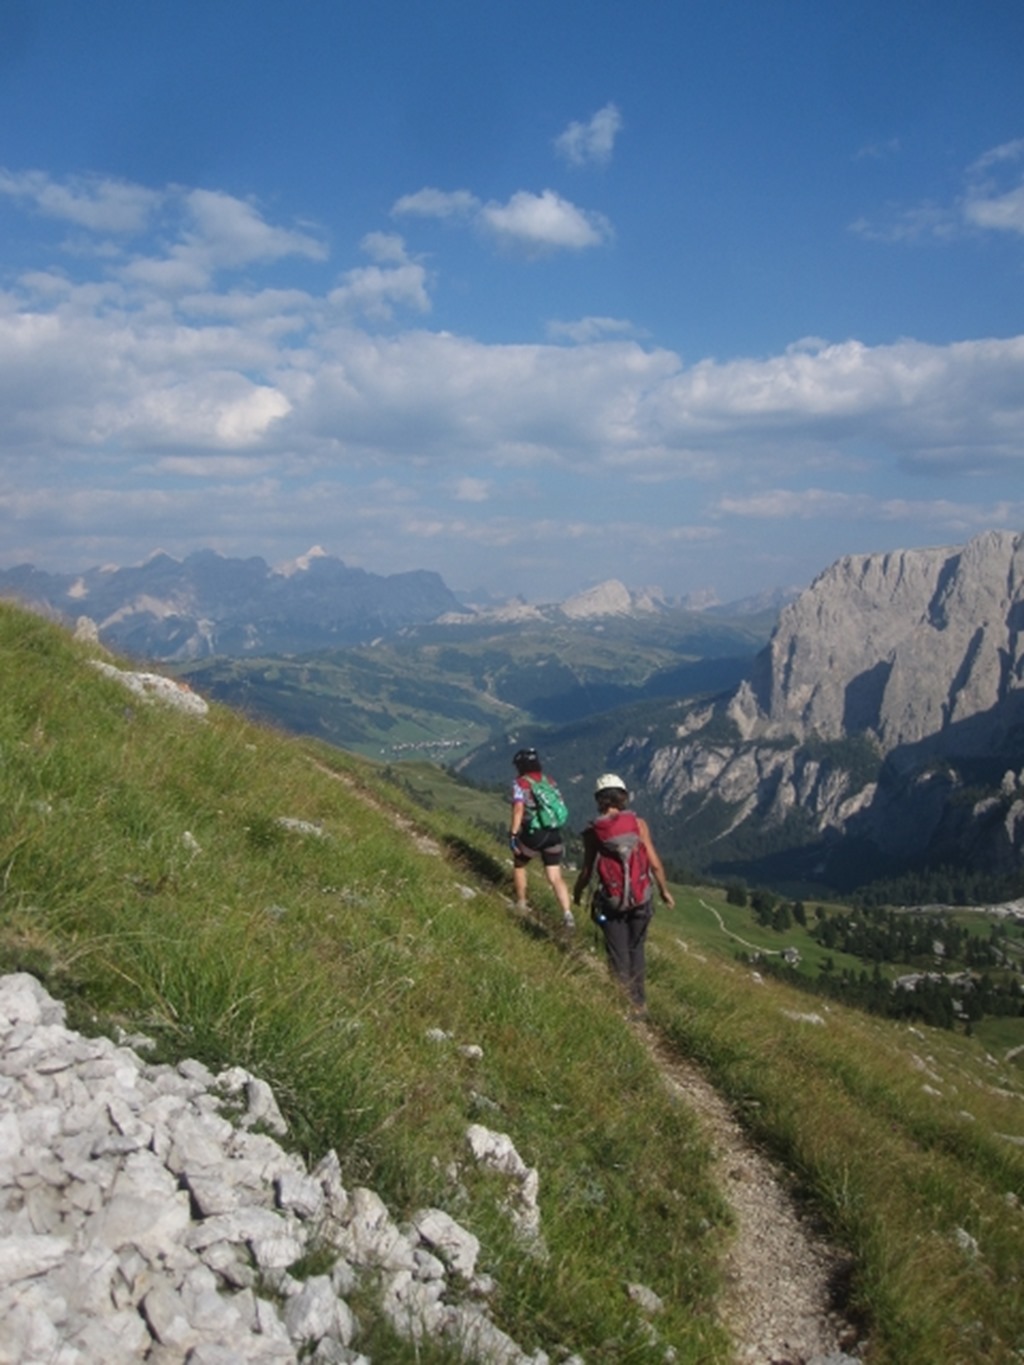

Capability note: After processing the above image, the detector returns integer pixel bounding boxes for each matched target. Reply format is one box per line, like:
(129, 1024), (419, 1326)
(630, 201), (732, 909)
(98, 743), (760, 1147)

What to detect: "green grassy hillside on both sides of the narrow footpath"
(0, 605), (1024, 1365)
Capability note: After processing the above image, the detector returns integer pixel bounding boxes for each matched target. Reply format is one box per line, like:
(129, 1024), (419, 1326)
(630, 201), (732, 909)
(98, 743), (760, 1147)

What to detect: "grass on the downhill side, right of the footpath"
(651, 939), (1024, 1365)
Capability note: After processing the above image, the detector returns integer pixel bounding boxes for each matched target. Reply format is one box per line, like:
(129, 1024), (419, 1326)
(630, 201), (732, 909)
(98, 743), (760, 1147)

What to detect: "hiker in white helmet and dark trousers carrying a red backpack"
(572, 773), (676, 1014)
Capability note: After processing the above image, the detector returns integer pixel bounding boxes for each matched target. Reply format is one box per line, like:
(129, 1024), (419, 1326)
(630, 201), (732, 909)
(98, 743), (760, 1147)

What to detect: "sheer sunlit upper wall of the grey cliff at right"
(752, 531), (1024, 753)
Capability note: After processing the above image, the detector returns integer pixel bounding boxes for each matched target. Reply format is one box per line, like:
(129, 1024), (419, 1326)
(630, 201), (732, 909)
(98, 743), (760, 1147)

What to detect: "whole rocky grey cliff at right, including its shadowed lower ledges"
(613, 532), (1024, 879)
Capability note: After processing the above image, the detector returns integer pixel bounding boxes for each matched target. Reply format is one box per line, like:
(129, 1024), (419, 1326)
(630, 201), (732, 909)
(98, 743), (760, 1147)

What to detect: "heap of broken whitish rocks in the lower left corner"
(0, 973), (579, 1365)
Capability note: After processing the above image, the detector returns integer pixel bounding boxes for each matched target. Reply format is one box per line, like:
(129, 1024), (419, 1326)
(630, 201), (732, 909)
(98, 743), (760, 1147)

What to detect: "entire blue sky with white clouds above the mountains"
(0, 0), (1024, 601)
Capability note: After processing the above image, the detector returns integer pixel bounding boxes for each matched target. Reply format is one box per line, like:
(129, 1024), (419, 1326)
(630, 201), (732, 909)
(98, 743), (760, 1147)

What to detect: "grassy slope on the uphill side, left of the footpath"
(0, 607), (728, 1362)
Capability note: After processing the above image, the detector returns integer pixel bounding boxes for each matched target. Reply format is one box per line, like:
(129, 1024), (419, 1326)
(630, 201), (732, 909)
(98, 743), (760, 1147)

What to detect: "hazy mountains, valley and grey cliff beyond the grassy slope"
(8, 531), (1024, 890)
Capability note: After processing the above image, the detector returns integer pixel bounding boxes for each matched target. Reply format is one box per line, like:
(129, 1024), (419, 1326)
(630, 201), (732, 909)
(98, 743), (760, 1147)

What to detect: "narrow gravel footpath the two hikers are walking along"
(317, 764), (857, 1365)
